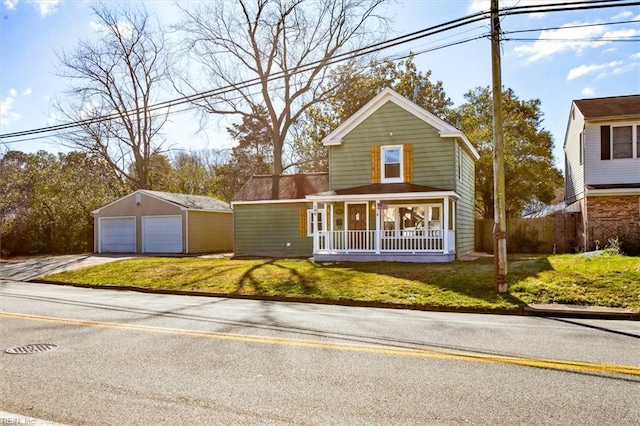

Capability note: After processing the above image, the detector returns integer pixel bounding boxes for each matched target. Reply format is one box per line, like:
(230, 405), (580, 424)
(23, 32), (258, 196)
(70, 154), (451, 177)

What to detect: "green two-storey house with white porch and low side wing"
(232, 89), (479, 262)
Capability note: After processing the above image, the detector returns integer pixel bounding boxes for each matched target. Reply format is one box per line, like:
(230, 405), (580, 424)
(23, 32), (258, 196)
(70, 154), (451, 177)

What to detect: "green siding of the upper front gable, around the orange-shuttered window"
(329, 102), (455, 190)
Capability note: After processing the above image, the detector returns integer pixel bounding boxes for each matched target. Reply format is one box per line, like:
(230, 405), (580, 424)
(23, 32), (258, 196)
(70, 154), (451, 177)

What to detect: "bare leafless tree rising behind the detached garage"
(56, 5), (169, 189)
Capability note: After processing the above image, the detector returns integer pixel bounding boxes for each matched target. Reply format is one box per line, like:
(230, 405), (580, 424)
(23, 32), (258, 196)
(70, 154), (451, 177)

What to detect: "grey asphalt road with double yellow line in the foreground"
(0, 279), (640, 425)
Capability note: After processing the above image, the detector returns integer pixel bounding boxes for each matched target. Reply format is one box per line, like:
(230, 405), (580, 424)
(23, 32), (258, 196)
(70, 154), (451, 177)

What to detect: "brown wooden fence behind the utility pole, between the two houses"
(475, 214), (577, 253)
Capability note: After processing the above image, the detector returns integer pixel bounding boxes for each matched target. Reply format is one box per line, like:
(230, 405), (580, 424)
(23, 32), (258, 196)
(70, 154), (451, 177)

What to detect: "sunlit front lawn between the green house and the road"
(45, 255), (640, 312)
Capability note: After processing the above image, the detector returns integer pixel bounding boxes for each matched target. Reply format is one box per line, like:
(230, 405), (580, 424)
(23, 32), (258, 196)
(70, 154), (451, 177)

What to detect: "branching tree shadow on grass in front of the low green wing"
(234, 259), (320, 296)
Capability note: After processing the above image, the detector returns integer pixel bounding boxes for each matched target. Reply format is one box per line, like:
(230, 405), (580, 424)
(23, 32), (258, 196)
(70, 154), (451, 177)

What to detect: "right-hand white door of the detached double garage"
(142, 216), (182, 253)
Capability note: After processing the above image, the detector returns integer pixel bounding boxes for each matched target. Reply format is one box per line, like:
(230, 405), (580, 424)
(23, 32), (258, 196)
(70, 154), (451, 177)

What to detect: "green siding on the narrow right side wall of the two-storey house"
(456, 142), (475, 257)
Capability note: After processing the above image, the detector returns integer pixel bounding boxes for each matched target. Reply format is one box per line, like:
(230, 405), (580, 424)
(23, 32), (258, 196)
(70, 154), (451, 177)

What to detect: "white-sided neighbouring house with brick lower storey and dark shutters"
(564, 95), (640, 253)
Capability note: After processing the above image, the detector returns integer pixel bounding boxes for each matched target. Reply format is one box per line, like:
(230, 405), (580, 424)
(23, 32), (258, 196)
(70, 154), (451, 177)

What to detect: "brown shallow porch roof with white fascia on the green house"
(306, 183), (460, 201)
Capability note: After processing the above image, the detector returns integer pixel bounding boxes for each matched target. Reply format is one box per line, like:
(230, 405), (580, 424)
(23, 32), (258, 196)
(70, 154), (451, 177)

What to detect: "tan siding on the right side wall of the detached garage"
(188, 211), (233, 253)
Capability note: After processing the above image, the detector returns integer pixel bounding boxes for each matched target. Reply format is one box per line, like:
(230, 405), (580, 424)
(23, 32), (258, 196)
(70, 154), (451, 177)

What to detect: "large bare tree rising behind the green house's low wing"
(175, 0), (386, 196)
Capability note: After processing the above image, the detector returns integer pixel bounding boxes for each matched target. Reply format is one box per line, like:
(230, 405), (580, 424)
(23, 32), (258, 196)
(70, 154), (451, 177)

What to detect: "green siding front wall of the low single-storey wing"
(233, 202), (313, 257)
